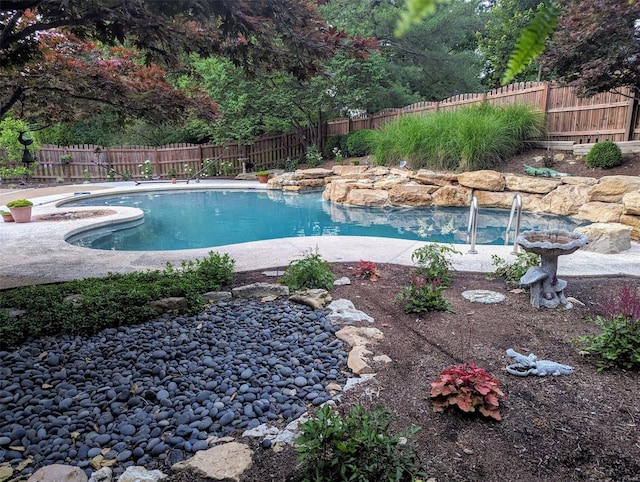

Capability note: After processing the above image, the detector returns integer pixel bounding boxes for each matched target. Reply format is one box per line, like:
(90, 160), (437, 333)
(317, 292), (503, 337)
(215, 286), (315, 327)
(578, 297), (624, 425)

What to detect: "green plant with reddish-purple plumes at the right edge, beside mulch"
(573, 286), (640, 371)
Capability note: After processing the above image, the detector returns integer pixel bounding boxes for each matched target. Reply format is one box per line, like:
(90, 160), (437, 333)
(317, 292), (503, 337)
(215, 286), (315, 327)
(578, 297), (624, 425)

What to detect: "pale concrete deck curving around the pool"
(0, 180), (640, 289)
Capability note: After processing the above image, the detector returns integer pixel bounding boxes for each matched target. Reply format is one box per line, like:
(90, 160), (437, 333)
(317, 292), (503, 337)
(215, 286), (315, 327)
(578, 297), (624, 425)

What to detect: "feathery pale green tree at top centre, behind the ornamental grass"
(321, 0), (484, 100)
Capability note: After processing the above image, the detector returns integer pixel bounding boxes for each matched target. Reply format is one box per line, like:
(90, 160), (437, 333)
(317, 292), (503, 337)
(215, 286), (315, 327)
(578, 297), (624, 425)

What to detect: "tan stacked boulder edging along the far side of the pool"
(267, 166), (640, 241)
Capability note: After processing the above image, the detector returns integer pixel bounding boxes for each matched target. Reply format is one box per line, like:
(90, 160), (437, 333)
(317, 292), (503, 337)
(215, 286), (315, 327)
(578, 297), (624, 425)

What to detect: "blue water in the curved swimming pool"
(65, 190), (580, 251)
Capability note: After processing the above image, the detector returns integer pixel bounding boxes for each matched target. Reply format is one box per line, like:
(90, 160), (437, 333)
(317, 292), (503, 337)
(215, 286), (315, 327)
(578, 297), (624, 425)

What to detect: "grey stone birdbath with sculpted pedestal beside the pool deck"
(516, 230), (589, 309)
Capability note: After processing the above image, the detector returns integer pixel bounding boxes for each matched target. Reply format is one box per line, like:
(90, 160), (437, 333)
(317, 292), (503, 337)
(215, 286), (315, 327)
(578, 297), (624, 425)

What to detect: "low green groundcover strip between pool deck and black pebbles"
(0, 252), (235, 347)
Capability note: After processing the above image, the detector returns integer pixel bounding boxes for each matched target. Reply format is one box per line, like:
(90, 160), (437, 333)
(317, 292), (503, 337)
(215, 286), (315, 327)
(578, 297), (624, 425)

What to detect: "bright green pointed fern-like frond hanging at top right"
(502, 2), (560, 85)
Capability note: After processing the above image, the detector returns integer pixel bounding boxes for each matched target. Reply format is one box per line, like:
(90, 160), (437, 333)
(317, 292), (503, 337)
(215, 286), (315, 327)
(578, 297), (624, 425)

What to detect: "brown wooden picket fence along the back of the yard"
(26, 82), (640, 182)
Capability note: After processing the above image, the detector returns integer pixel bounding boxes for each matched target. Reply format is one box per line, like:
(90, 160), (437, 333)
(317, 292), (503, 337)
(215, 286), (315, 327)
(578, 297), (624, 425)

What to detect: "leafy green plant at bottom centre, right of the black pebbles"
(295, 405), (425, 482)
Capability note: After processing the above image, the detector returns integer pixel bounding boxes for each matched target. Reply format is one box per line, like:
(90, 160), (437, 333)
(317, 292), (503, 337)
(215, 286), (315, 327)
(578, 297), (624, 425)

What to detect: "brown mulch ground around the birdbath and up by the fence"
(170, 150), (640, 482)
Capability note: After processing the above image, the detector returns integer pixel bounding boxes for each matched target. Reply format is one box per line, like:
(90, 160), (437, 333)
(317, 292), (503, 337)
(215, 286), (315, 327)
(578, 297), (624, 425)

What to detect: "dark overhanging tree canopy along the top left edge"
(0, 0), (365, 124)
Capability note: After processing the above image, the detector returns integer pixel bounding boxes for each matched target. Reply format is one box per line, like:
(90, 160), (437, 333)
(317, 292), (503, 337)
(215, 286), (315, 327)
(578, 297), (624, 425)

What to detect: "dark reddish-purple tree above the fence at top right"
(542, 0), (640, 96)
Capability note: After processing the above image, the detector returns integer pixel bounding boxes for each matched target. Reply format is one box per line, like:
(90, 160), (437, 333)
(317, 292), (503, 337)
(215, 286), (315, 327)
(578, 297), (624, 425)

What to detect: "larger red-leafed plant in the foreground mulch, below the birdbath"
(431, 363), (504, 420)
